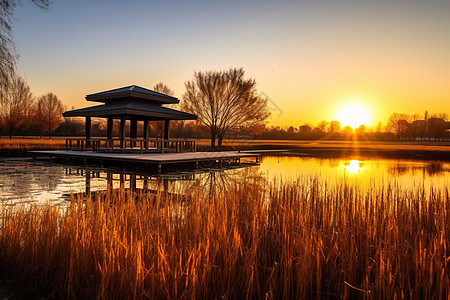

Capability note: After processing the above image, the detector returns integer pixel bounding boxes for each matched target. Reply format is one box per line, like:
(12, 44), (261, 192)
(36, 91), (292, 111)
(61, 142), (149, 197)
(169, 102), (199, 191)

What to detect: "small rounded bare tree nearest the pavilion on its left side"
(36, 93), (64, 137)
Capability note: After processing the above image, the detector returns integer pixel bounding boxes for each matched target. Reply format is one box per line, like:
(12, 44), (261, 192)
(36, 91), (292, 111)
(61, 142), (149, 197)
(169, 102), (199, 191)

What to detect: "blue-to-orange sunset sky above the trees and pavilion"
(9, 0), (450, 127)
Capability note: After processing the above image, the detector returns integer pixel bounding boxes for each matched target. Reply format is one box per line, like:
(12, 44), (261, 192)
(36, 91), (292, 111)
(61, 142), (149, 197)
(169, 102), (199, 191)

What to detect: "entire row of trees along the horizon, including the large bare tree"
(0, 69), (450, 147)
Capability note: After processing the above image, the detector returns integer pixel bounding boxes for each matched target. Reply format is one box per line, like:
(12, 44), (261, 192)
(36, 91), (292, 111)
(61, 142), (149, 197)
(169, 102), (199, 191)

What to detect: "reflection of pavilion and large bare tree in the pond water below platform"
(61, 162), (263, 200)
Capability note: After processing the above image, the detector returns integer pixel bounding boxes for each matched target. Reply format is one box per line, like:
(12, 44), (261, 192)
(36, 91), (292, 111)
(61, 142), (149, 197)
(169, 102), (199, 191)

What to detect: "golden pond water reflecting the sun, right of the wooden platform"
(260, 156), (450, 188)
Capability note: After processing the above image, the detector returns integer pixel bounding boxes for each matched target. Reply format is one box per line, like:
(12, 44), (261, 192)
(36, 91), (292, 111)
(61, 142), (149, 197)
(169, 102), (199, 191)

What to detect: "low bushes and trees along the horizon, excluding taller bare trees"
(0, 114), (450, 141)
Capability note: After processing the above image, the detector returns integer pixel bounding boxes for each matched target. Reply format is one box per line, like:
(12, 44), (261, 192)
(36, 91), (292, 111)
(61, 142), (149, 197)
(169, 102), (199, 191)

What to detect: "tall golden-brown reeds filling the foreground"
(0, 178), (450, 299)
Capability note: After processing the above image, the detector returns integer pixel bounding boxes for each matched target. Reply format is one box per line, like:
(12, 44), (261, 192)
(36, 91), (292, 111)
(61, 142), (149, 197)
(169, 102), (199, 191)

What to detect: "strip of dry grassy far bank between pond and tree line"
(0, 138), (450, 161)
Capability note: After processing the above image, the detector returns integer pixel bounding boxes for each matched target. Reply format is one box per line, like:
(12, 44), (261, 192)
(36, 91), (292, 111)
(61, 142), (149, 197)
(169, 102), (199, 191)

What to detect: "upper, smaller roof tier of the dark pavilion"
(86, 85), (180, 105)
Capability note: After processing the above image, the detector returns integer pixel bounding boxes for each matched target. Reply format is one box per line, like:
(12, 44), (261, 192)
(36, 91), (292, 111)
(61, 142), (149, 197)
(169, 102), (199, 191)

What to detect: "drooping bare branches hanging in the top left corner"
(0, 0), (50, 96)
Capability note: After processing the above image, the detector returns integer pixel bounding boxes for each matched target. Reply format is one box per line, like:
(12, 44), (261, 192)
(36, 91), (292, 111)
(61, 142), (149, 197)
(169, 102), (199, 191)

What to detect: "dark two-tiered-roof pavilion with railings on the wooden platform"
(63, 85), (197, 153)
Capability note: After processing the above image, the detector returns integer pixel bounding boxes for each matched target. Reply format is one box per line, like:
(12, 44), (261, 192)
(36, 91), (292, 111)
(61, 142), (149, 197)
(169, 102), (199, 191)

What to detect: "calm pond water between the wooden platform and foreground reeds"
(0, 156), (450, 205)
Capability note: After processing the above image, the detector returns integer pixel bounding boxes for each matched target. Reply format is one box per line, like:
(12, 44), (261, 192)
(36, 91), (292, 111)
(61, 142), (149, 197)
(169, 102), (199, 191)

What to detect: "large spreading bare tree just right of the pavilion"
(183, 68), (270, 147)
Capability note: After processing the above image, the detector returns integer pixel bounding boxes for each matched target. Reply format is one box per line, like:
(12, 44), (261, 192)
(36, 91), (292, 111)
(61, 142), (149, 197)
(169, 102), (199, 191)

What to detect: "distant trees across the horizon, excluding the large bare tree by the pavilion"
(0, 77), (450, 140)
